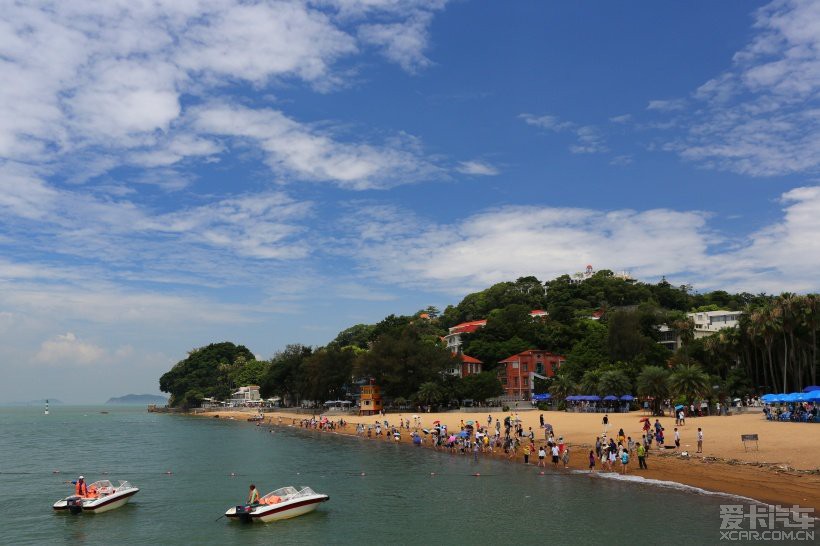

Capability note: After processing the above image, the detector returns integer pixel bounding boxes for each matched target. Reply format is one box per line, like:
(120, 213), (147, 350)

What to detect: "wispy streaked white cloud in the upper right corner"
(650, 0), (820, 176)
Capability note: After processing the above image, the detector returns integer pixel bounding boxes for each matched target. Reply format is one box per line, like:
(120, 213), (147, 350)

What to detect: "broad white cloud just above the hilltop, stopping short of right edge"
(344, 201), (709, 294)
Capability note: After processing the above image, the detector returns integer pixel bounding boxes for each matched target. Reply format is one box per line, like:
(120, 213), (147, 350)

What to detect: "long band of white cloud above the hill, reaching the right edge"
(348, 186), (820, 295)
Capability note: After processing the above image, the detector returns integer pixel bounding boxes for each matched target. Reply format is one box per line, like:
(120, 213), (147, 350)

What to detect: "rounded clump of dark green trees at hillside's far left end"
(159, 341), (254, 407)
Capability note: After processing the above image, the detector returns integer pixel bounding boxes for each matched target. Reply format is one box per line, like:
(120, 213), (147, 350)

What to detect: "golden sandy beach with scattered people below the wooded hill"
(205, 410), (820, 513)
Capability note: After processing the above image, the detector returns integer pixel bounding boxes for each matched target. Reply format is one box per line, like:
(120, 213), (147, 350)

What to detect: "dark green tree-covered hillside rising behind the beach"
(160, 270), (820, 404)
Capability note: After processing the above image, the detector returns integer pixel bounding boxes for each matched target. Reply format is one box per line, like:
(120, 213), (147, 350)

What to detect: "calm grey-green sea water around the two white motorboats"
(0, 406), (748, 544)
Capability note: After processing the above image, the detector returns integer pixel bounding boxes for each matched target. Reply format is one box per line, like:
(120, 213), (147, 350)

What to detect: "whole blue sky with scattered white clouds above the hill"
(0, 0), (820, 403)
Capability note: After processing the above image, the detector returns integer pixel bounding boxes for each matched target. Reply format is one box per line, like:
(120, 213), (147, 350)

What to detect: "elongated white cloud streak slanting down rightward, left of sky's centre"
(194, 104), (442, 190)
